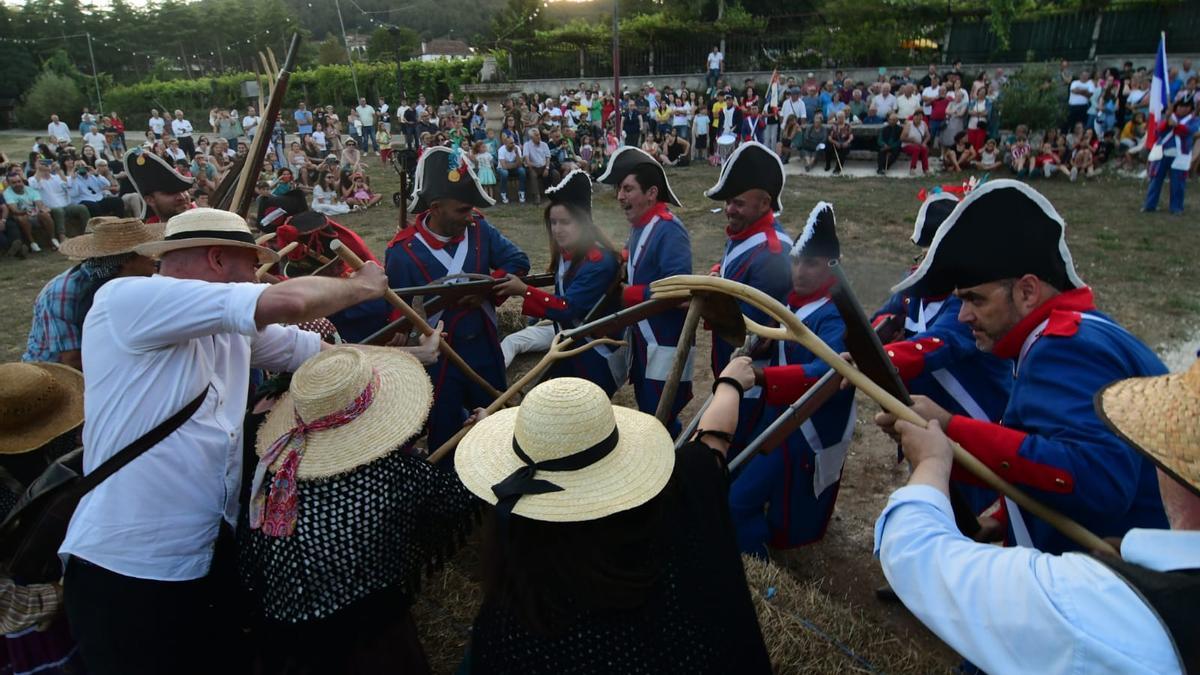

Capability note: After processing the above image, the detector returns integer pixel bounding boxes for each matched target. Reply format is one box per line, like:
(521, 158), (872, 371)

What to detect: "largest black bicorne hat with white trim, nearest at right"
(892, 179), (1085, 297)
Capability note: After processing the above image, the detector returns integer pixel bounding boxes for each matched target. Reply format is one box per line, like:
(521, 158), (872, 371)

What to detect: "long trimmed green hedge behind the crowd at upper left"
(104, 58), (482, 121)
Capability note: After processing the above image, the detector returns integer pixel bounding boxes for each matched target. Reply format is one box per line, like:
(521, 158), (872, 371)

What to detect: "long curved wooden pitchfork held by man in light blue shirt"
(650, 274), (1117, 555)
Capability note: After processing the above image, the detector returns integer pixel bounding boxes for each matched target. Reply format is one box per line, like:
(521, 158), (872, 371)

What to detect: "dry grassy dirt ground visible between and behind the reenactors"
(0, 135), (1200, 671)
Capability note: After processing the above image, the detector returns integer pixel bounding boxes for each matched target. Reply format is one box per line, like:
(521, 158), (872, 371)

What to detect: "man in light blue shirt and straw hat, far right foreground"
(875, 362), (1200, 674)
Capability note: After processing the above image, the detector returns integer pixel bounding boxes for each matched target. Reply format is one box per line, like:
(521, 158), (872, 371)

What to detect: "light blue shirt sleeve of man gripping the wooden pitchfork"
(875, 485), (1180, 674)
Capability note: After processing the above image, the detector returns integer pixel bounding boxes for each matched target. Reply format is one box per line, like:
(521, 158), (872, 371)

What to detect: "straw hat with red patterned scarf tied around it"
(254, 346), (433, 480)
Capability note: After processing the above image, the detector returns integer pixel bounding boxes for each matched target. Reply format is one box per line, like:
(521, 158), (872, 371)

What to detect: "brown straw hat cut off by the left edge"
(0, 363), (83, 455)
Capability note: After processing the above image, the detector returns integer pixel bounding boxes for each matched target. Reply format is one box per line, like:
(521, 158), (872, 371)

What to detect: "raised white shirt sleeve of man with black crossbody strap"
(99, 275), (268, 352)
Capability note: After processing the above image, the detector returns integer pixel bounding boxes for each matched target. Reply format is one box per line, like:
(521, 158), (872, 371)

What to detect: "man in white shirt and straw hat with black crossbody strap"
(60, 209), (388, 675)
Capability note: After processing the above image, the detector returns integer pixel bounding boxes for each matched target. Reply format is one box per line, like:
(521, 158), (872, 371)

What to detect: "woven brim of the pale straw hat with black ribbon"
(455, 406), (674, 522)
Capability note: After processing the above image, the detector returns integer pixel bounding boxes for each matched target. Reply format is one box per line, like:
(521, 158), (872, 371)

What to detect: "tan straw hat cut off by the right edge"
(1096, 360), (1200, 495)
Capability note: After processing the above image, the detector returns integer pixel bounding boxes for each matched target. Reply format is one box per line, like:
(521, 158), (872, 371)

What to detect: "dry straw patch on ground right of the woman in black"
(742, 556), (946, 674)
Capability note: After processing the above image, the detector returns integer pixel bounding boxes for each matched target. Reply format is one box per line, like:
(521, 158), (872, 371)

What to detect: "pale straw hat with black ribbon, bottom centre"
(455, 377), (674, 522)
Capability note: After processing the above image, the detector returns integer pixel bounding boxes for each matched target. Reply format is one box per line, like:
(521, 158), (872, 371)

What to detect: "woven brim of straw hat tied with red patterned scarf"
(254, 347), (433, 480)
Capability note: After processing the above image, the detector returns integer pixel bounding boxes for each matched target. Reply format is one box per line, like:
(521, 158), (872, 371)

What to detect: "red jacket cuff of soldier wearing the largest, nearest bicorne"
(946, 414), (1075, 495)
